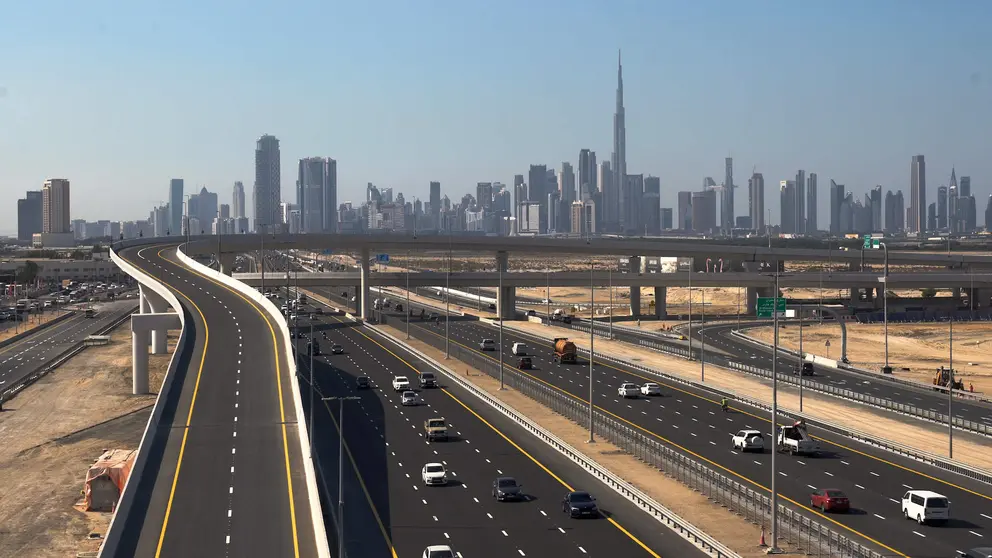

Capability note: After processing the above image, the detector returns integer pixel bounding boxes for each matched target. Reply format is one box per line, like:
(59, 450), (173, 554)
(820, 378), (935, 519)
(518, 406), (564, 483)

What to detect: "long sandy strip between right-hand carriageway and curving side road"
(382, 286), (989, 469)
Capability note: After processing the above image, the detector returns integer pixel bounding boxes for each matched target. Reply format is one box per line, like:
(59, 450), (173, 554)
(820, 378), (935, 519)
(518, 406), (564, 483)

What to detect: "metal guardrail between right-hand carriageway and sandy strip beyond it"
(511, 326), (992, 490)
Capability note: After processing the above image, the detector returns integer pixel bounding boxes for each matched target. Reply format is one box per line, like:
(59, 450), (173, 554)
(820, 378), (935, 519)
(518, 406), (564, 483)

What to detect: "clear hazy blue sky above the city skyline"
(0, 0), (992, 233)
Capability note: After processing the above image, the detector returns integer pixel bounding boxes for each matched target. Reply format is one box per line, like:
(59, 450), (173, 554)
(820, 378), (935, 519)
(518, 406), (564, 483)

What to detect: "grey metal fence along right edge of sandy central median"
(378, 317), (883, 558)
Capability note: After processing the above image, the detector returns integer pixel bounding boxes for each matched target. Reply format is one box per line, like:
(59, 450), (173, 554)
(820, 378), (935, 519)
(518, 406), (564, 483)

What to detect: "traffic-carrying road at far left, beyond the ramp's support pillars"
(0, 300), (137, 398)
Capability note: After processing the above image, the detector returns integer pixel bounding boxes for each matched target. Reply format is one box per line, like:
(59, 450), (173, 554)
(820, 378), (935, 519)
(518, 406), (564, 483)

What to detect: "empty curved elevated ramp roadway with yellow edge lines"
(118, 243), (316, 558)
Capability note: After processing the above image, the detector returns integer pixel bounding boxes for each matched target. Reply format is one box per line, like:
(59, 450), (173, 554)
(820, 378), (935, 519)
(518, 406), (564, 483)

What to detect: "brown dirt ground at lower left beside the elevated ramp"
(0, 324), (179, 558)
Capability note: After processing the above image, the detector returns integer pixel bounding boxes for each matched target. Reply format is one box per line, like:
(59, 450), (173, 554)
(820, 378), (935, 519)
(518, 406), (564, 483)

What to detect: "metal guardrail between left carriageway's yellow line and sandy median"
(365, 317), (740, 558)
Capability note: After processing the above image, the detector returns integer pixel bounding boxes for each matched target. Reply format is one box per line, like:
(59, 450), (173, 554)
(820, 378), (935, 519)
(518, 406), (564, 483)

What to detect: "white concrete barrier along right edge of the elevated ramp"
(177, 249), (331, 558)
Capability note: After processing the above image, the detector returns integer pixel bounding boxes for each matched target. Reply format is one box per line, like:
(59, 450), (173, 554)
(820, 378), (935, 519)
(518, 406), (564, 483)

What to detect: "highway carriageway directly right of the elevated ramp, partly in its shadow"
(297, 301), (703, 558)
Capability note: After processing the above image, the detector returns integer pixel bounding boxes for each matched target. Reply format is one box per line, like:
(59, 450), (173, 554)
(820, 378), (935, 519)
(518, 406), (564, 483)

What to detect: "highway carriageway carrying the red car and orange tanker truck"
(314, 293), (992, 558)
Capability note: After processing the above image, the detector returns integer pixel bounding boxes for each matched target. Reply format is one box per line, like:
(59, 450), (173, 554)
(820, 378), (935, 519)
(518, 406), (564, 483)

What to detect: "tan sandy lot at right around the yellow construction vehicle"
(748, 322), (992, 393)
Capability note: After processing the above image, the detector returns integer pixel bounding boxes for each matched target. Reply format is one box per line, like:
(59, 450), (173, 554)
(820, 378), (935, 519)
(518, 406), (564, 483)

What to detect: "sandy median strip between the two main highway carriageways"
(382, 326), (788, 558)
